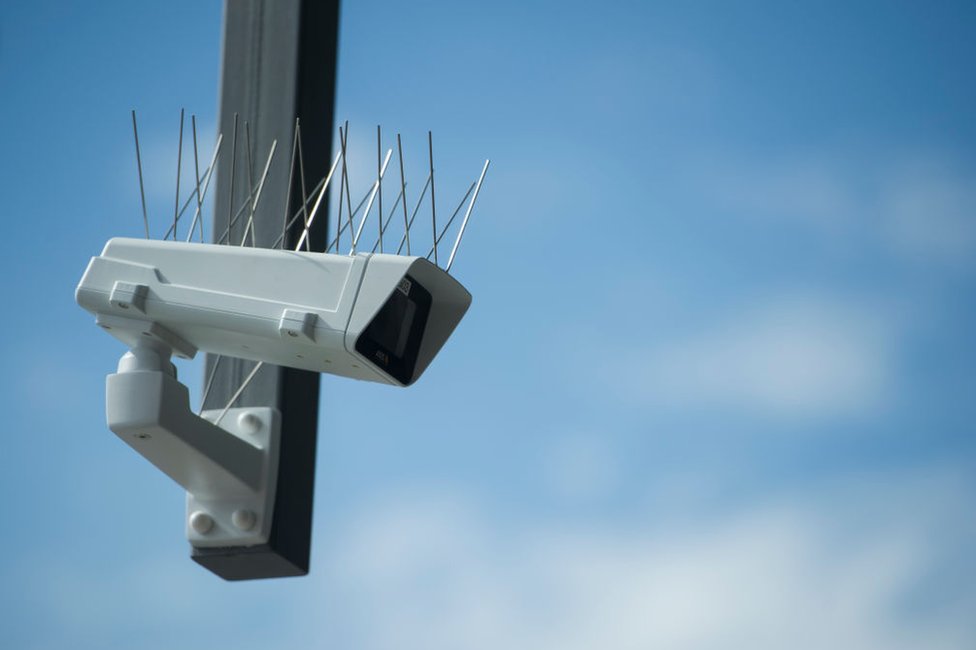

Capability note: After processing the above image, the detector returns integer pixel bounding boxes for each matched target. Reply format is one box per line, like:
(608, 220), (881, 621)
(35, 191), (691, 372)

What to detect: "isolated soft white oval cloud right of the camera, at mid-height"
(612, 296), (891, 418)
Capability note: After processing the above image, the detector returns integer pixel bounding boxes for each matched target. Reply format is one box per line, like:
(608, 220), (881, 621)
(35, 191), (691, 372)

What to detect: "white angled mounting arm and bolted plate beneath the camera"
(105, 337), (280, 547)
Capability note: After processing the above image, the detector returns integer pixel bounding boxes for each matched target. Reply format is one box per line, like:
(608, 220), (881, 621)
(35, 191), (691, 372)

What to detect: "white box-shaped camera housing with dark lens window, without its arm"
(75, 238), (471, 386)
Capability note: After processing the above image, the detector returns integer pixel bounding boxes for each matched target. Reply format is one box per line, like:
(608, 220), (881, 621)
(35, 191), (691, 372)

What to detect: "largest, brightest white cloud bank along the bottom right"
(304, 466), (976, 650)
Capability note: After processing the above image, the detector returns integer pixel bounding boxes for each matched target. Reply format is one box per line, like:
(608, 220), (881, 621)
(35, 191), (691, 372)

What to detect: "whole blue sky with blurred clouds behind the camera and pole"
(0, 2), (976, 649)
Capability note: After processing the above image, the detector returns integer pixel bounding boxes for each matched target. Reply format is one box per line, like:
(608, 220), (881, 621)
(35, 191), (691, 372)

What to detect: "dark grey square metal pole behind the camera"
(192, 0), (339, 580)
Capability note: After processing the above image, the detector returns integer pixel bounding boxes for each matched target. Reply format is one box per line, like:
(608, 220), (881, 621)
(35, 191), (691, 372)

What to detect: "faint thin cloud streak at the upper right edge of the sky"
(685, 151), (976, 267)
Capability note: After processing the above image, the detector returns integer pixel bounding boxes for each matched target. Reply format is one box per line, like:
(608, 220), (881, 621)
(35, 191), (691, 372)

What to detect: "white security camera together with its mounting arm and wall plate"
(75, 238), (471, 548)
